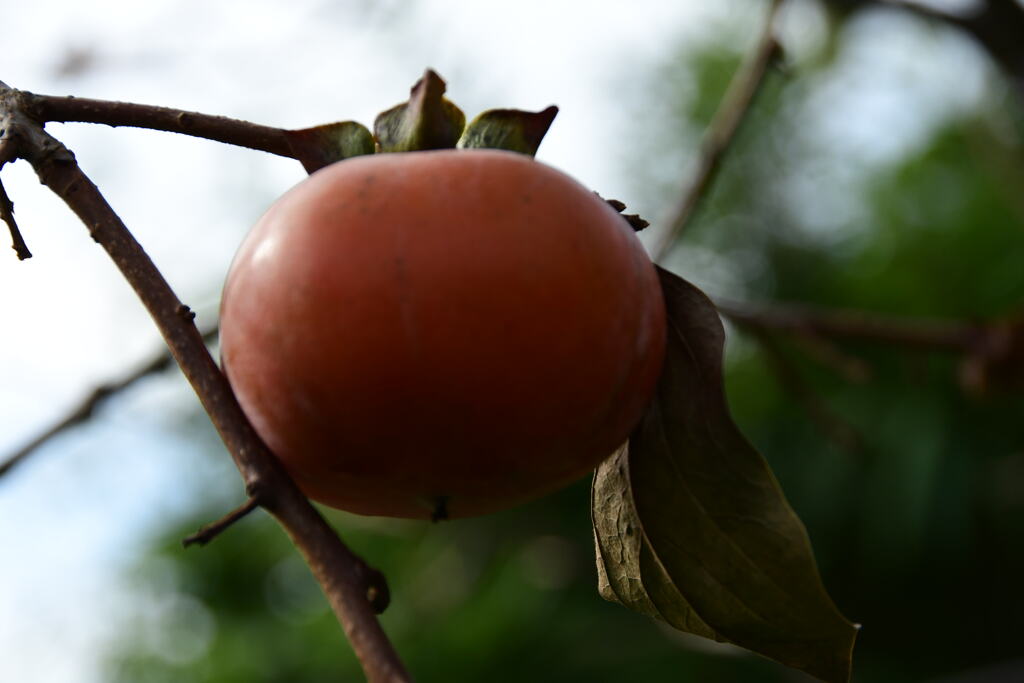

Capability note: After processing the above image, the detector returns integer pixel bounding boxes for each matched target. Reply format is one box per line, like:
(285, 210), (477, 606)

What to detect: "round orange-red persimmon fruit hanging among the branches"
(220, 150), (666, 518)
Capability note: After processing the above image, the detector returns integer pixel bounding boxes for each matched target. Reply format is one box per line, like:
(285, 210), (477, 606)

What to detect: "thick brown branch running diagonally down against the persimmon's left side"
(0, 84), (411, 683)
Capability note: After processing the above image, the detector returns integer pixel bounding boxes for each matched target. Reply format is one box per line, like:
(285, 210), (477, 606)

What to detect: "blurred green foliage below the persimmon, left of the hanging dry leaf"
(112, 482), (791, 683)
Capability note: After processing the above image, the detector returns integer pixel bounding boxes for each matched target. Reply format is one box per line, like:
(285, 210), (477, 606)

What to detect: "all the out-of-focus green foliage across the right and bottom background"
(103, 9), (1024, 683)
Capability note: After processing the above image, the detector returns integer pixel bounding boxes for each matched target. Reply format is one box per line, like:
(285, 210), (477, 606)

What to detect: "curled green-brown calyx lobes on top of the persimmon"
(288, 69), (558, 173)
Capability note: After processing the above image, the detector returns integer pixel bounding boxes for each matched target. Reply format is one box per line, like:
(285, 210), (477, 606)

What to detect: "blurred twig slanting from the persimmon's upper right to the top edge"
(653, 0), (782, 262)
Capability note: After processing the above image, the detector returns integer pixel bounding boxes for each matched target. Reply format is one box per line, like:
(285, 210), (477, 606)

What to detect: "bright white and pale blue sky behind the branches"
(0, 0), (981, 683)
